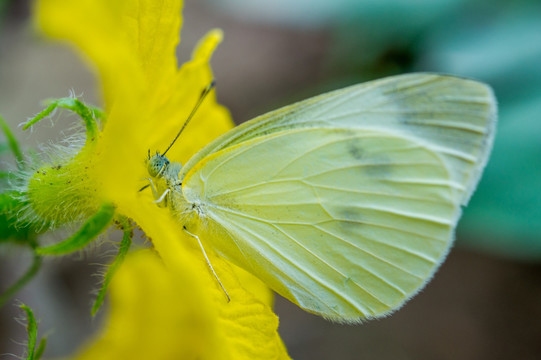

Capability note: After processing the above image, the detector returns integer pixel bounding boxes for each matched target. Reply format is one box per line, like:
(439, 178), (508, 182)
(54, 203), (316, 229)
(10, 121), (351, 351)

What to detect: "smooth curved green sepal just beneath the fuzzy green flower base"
(36, 203), (115, 255)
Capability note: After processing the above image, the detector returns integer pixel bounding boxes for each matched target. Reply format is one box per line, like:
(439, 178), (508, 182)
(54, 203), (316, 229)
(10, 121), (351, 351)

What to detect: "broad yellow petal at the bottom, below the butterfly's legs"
(76, 233), (289, 360)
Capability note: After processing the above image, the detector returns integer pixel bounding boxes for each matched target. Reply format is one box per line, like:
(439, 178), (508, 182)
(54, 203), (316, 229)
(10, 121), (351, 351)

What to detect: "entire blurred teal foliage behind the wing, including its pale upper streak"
(422, 8), (541, 261)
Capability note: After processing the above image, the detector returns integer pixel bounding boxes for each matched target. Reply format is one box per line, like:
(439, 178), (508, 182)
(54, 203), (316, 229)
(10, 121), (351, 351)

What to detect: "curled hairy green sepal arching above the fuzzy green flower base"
(23, 97), (103, 142)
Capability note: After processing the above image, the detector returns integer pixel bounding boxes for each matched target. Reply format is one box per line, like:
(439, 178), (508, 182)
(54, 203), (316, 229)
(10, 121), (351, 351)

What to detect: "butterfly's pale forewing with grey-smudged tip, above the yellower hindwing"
(180, 73), (496, 204)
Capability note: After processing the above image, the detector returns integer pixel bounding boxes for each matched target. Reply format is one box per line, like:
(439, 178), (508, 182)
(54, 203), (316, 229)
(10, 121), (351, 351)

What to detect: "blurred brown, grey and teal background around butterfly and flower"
(0, 0), (541, 360)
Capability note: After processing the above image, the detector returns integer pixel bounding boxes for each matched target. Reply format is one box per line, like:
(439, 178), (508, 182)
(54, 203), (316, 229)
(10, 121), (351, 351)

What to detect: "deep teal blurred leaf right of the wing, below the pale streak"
(460, 95), (541, 261)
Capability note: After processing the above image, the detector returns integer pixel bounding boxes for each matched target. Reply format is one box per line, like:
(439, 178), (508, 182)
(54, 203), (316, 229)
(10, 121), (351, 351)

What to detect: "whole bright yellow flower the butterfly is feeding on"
(30, 0), (288, 359)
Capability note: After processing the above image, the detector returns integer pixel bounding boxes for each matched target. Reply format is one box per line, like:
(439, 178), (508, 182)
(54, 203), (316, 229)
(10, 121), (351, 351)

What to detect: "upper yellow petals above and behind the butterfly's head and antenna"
(37, 0), (233, 202)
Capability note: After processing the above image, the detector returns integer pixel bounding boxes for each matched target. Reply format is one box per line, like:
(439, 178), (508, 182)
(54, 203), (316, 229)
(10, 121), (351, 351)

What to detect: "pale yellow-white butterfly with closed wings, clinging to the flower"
(142, 73), (497, 323)
